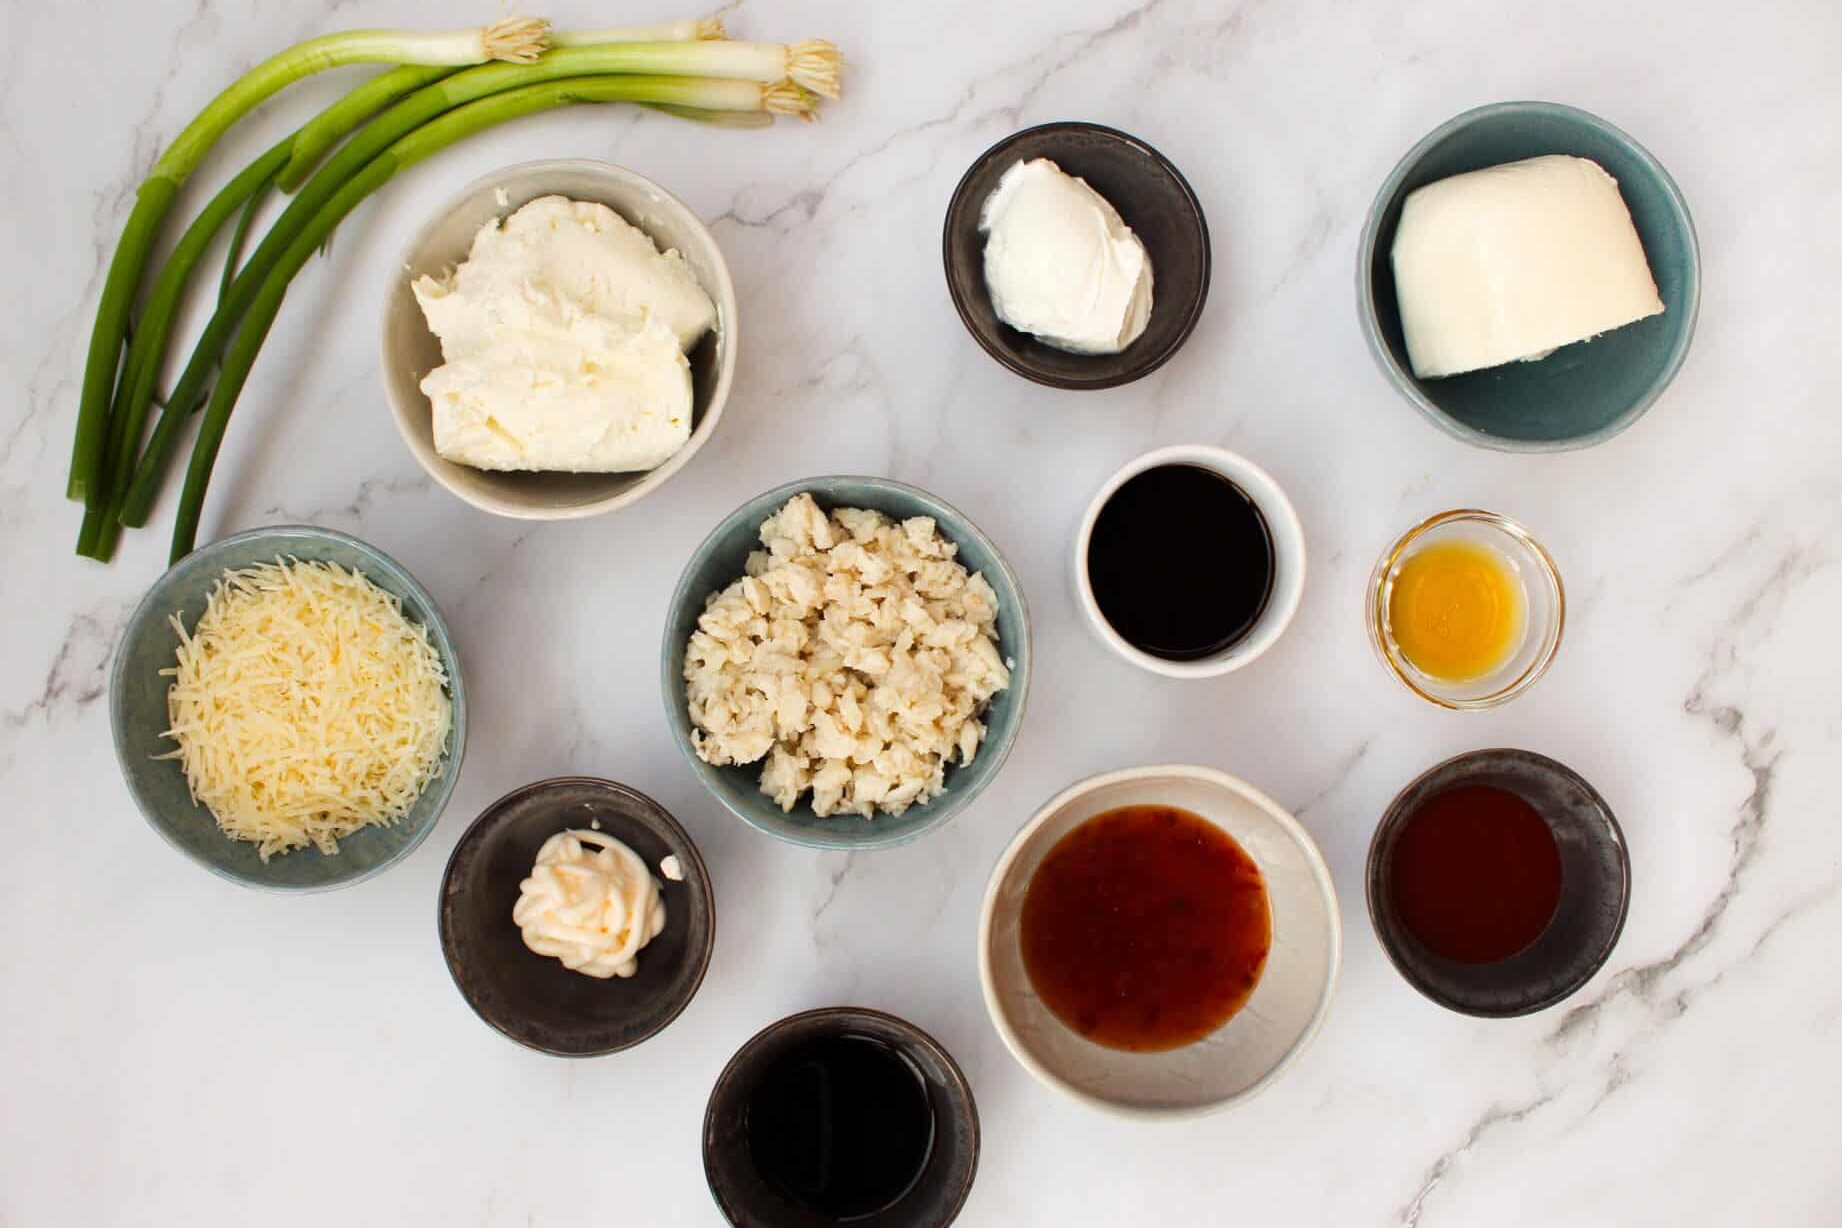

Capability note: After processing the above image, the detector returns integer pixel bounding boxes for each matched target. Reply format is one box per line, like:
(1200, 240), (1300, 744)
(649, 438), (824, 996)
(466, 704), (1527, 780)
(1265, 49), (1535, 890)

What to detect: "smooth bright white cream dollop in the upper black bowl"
(978, 158), (1151, 353)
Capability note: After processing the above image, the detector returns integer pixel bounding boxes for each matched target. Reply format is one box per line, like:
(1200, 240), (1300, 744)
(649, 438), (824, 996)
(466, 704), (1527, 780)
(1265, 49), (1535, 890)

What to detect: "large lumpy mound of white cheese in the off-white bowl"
(411, 197), (717, 473)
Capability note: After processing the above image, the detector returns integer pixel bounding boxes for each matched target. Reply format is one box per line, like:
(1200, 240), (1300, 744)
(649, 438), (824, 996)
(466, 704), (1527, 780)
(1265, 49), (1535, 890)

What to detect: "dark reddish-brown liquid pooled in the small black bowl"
(1389, 784), (1560, 963)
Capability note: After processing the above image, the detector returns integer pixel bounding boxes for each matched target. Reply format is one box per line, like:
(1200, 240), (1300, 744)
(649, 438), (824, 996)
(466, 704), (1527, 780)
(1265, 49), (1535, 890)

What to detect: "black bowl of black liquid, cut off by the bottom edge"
(704, 1007), (978, 1228)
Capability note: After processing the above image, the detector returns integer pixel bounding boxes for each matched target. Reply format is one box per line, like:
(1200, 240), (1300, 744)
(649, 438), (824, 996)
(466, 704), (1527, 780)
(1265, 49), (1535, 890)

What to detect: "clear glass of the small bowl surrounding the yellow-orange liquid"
(1367, 508), (1568, 711)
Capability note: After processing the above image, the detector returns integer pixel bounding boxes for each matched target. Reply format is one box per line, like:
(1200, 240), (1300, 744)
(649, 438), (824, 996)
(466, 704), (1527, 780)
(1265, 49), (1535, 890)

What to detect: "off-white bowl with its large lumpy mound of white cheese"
(383, 160), (737, 519)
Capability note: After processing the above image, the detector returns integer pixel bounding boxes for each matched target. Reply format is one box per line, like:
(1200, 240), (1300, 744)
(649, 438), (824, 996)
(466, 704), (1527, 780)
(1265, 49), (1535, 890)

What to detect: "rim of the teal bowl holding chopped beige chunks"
(659, 473), (1032, 852)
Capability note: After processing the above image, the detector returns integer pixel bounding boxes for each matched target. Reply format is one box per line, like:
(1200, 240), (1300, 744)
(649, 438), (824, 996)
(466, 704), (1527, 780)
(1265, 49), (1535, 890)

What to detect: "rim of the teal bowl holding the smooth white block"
(1356, 99), (1702, 453)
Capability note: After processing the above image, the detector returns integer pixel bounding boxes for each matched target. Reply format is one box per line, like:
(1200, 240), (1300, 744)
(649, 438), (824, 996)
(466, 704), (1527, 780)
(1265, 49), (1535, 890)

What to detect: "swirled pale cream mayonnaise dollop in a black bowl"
(512, 832), (665, 979)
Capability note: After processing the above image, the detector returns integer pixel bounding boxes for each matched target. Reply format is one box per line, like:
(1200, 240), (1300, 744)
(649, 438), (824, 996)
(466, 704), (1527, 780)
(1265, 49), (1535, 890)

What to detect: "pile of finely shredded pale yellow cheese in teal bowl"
(160, 560), (453, 862)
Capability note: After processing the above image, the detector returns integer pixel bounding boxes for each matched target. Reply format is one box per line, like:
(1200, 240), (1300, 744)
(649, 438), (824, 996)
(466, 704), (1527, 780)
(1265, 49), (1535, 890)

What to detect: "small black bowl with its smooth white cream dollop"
(943, 122), (1210, 388)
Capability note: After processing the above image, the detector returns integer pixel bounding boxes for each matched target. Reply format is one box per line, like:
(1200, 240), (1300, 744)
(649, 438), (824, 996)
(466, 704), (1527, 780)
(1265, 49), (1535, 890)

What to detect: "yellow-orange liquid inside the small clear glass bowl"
(1387, 541), (1529, 683)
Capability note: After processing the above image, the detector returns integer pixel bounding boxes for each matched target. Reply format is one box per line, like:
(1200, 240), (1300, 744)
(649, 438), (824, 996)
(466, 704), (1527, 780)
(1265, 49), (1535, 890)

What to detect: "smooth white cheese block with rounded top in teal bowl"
(1393, 155), (1663, 379)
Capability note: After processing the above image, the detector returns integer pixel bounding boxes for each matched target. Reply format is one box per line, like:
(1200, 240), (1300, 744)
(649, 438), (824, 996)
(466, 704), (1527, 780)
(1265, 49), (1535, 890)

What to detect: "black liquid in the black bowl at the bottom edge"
(748, 1035), (934, 1221)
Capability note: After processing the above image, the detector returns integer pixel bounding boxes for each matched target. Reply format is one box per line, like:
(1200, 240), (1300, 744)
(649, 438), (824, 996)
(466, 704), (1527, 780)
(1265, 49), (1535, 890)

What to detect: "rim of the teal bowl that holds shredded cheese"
(109, 525), (466, 895)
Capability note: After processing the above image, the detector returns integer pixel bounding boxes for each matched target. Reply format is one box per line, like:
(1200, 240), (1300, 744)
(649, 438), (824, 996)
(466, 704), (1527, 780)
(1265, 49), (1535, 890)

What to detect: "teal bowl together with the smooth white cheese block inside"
(1356, 101), (1702, 453)
